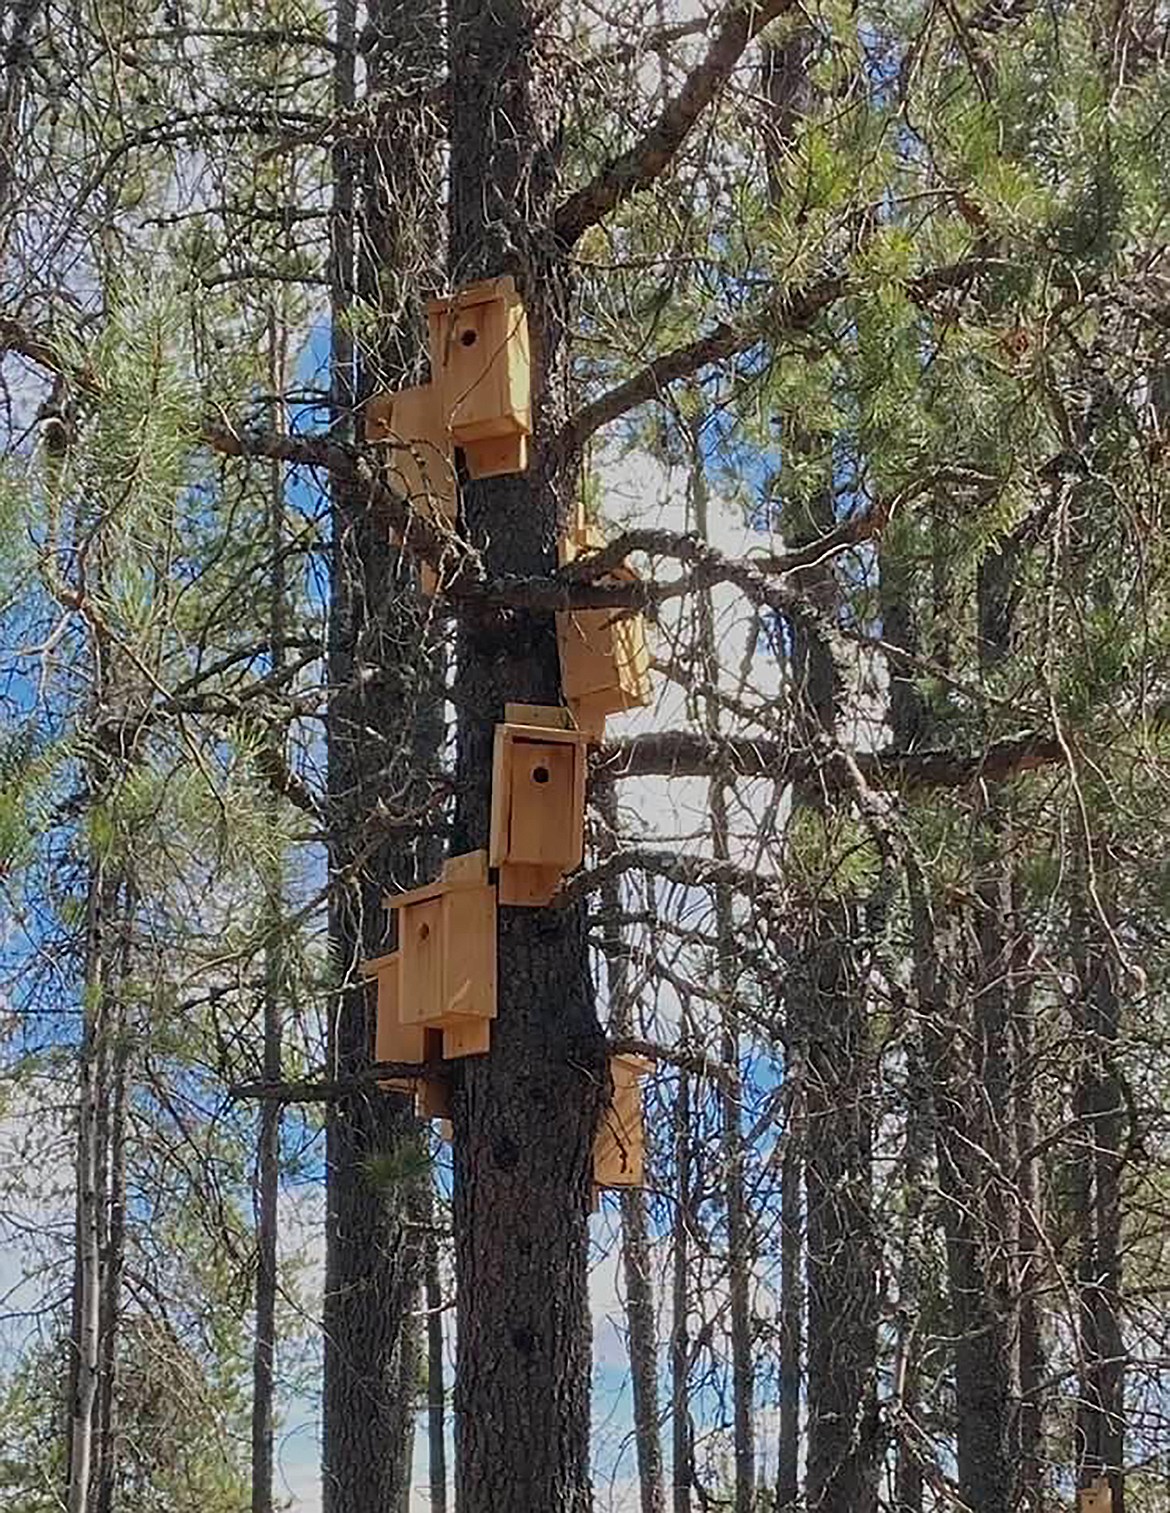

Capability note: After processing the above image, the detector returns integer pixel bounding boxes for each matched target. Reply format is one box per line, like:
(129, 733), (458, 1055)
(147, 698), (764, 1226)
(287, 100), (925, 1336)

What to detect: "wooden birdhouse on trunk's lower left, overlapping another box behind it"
(386, 852), (496, 1058)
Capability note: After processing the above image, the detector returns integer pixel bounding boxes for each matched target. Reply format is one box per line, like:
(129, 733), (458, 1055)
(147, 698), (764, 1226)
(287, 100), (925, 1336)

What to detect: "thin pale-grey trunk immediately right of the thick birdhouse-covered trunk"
(593, 779), (666, 1513)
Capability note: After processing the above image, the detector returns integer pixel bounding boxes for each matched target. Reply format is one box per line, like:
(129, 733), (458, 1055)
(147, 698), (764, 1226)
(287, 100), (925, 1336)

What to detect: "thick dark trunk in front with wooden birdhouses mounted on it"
(448, 11), (605, 1513)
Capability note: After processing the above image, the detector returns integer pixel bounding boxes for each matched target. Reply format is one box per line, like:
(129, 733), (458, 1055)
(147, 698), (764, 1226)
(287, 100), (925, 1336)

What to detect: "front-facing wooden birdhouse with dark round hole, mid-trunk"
(490, 704), (589, 908)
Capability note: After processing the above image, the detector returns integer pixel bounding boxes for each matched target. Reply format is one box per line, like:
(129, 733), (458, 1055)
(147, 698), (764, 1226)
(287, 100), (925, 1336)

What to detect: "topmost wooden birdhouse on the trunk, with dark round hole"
(427, 277), (531, 478)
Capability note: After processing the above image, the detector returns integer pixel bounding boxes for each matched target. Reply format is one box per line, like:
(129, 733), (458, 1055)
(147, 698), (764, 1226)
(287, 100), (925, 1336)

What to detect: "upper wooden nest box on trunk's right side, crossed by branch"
(557, 520), (651, 741)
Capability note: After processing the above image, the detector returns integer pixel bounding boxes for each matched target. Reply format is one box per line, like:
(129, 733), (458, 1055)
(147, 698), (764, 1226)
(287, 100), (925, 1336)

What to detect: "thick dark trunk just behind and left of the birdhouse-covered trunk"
(322, 0), (442, 1513)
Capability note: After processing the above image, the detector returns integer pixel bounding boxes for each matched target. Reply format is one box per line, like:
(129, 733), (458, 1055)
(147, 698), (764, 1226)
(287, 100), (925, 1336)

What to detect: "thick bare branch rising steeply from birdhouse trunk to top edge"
(554, 0), (795, 247)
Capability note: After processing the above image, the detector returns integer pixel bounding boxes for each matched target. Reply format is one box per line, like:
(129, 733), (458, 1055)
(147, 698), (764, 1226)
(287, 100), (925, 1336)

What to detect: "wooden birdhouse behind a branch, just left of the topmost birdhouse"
(365, 384), (459, 596)
